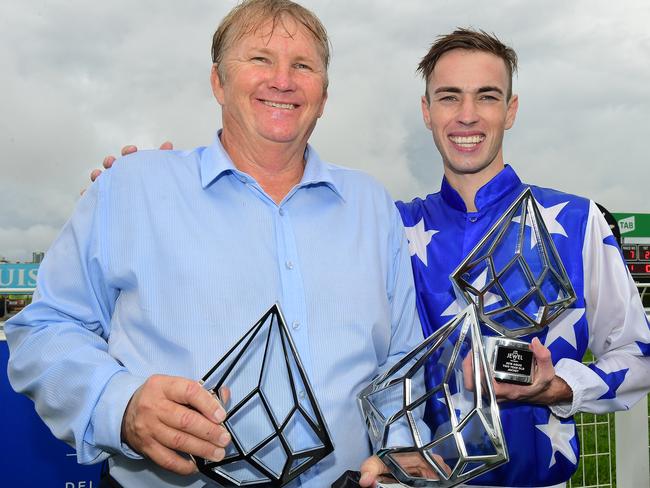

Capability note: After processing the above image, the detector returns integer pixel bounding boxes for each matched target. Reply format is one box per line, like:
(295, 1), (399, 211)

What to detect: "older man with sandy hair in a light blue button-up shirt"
(5, 0), (422, 487)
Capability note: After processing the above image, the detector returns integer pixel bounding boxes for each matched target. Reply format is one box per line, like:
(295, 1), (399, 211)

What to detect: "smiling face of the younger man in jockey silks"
(422, 49), (518, 176)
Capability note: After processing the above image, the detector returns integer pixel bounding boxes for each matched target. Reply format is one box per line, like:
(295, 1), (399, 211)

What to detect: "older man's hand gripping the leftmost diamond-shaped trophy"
(122, 375), (230, 475)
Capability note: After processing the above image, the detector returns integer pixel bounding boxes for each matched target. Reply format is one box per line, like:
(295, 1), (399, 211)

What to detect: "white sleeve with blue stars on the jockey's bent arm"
(552, 202), (650, 417)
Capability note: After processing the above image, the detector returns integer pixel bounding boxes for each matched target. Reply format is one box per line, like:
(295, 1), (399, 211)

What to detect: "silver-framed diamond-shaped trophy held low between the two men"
(346, 304), (508, 488)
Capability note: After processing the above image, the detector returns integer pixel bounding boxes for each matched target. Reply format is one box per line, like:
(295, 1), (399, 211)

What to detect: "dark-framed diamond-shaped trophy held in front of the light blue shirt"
(194, 304), (334, 487)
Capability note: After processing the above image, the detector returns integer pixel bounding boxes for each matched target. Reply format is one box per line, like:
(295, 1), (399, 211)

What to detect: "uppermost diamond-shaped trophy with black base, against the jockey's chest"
(450, 188), (576, 384)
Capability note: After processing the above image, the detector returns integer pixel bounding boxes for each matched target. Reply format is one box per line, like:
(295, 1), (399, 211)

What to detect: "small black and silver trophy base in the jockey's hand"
(485, 337), (535, 385)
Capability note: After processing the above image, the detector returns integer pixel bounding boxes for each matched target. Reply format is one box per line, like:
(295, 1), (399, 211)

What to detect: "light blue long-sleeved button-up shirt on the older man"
(6, 137), (422, 487)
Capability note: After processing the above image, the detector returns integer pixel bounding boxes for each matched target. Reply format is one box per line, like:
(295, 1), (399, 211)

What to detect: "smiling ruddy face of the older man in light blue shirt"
(212, 18), (327, 149)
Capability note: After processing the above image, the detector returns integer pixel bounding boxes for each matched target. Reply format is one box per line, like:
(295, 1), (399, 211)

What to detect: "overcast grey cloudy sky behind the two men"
(0, 0), (650, 260)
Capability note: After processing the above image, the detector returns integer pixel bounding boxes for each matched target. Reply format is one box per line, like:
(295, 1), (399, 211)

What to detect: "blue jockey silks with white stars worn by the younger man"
(397, 166), (650, 486)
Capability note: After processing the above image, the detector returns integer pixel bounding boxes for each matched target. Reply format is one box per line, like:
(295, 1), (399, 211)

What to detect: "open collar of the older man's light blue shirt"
(200, 130), (343, 199)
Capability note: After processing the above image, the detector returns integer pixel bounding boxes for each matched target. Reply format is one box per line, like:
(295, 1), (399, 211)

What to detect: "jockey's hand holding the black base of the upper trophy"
(494, 337), (573, 405)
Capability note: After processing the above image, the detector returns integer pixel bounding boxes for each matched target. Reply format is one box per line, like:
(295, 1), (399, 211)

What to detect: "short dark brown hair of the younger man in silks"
(417, 27), (517, 100)
